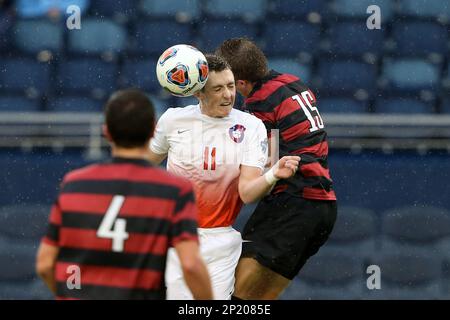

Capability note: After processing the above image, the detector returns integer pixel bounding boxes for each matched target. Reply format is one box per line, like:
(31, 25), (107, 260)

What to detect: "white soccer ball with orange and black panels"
(156, 44), (209, 97)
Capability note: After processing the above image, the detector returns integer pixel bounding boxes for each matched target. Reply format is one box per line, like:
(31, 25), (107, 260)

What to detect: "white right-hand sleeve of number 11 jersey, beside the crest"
(241, 119), (268, 170)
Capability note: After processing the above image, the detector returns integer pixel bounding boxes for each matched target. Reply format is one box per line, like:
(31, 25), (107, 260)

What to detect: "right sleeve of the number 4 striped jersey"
(170, 182), (198, 246)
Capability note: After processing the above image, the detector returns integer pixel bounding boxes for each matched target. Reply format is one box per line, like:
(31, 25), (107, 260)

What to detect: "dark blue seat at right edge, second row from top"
(392, 21), (448, 56)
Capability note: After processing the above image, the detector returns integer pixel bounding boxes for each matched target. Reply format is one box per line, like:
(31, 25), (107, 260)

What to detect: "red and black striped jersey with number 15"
(244, 70), (336, 200)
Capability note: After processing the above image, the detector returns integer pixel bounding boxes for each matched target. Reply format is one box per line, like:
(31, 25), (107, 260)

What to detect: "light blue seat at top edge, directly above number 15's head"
(204, 0), (267, 21)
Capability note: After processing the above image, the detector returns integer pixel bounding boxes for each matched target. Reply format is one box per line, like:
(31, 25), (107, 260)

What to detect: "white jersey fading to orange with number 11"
(150, 105), (267, 228)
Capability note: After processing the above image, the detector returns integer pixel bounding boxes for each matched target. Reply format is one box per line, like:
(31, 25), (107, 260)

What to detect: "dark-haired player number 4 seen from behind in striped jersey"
(36, 89), (212, 299)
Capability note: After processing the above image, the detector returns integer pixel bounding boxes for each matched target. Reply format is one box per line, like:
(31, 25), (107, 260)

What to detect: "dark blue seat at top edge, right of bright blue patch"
(90, 0), (137, 20)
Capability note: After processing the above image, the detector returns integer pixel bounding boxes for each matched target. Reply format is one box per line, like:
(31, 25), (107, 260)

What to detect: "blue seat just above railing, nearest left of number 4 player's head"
(46, 96), (103, 112)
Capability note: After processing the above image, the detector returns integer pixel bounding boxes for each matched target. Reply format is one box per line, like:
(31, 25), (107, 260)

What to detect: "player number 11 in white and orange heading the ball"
(150, 55), (299, 300)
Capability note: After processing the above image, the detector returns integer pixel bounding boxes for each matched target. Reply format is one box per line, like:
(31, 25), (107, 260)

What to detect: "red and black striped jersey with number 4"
(43, 158), (198, 299)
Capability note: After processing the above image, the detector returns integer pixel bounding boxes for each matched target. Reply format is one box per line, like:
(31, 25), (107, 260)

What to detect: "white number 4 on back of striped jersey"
(97, 196), (128, 252)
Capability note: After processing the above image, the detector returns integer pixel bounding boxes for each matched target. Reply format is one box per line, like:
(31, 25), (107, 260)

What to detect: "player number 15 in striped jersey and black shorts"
(216, 38), (337, 299)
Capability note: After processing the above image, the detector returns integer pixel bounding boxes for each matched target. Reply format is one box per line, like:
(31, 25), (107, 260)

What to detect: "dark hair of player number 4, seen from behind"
(105, 89), (155, 148)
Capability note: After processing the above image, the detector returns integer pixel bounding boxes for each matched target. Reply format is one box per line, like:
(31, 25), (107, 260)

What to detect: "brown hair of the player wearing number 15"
(215, 38), (269, 82)
